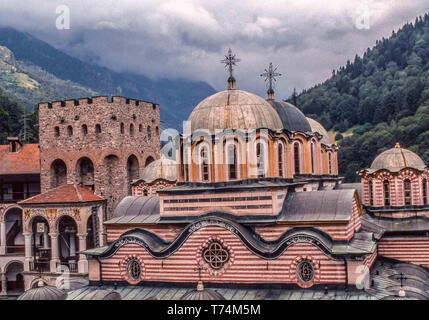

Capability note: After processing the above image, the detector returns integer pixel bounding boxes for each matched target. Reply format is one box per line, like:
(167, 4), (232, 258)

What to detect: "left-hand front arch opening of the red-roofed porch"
(30, 216), (51, 272)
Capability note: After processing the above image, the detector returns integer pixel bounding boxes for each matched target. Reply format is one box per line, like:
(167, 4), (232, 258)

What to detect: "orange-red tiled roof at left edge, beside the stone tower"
(0, 144), (40, 175)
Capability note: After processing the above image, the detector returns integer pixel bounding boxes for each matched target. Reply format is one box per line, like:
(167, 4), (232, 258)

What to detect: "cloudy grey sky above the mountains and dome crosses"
(0, 0), (429, 98)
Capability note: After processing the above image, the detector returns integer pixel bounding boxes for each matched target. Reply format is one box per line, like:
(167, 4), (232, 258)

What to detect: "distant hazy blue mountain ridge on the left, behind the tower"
(0, 27), (215, 129)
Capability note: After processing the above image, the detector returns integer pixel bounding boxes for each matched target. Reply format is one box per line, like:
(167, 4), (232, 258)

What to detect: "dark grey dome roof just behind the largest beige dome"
(268, 100), (311, 132)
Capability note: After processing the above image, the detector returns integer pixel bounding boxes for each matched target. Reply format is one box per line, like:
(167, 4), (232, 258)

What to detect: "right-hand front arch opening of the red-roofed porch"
(58, 216), (79, 272)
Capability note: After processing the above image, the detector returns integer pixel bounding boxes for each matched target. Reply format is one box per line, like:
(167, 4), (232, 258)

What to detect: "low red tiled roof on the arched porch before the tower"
(19, 184), (104, 205)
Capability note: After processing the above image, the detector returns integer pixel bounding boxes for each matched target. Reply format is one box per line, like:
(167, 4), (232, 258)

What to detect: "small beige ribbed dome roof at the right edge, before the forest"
(370, 143), (426, 172)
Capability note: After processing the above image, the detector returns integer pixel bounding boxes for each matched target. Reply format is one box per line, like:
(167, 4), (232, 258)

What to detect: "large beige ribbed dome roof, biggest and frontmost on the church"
(188, 89), (283, 133)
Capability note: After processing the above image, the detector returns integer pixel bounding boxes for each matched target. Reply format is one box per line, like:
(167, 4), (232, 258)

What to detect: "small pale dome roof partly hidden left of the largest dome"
(138, 158), (177, 183)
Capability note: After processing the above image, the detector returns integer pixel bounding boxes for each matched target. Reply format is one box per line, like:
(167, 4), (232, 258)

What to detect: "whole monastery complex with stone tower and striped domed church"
(0, 51), (429, 299)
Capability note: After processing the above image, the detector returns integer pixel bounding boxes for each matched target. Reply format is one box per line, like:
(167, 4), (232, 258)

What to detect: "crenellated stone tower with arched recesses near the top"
(39, 96), (160, 218)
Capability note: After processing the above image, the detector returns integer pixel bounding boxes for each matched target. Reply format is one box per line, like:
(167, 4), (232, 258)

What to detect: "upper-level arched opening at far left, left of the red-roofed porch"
(4, 207), (24, 254)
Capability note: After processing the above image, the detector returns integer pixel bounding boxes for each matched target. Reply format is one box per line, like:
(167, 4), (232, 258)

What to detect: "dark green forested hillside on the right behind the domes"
(290, 14), (429, 182)
